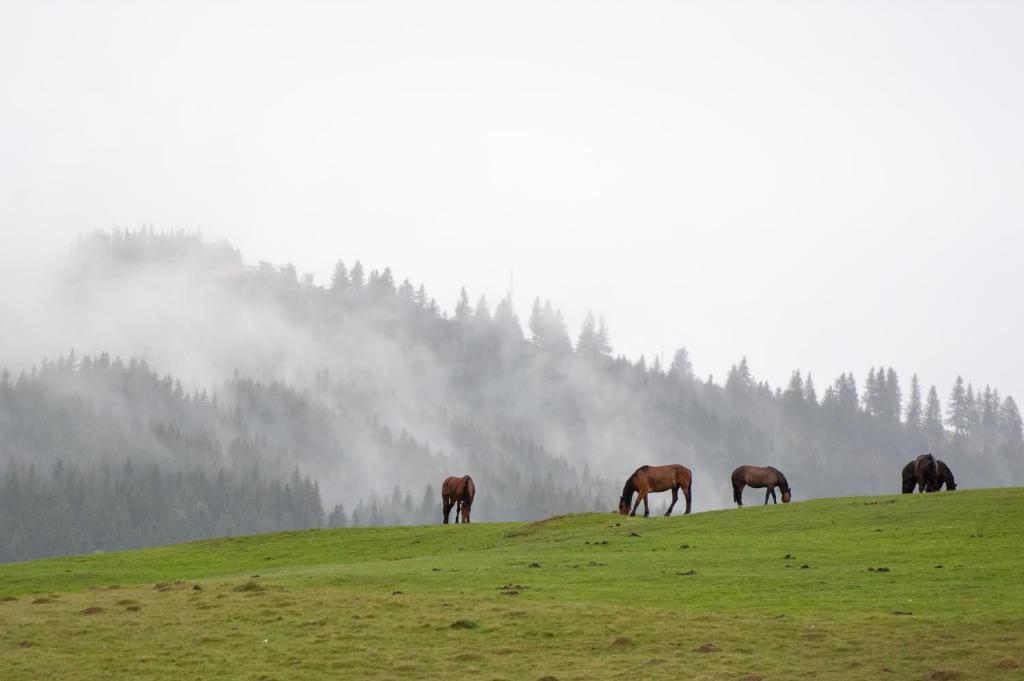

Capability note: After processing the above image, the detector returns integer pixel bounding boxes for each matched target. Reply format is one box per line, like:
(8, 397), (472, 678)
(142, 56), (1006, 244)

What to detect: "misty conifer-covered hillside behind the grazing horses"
(0, 229), (1024, 561)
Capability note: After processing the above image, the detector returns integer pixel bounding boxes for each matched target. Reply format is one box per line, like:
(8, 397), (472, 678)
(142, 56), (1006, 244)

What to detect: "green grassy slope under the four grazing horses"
(0, 488), (1024, 681)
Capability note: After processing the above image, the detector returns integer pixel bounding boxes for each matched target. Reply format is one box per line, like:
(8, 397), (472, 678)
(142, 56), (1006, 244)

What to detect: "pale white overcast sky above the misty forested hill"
(0, 0), (1024, 397)
